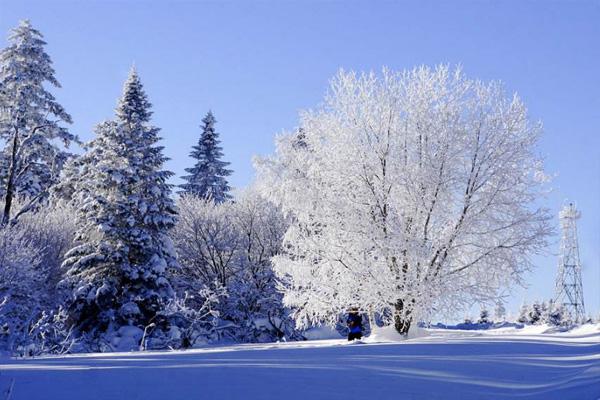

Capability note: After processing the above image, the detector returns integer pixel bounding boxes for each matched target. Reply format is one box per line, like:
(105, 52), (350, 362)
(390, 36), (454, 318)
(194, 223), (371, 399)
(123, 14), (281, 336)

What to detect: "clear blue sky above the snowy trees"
(0, 0), (600, 315)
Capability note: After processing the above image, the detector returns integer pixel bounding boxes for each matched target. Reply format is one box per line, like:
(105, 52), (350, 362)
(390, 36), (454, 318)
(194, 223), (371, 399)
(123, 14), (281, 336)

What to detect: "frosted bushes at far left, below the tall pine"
(0, 203), (75, 354)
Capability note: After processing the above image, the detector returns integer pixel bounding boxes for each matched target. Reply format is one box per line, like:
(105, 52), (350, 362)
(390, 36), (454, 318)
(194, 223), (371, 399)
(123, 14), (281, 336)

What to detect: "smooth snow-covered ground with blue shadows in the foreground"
(0, 325), (600, 400)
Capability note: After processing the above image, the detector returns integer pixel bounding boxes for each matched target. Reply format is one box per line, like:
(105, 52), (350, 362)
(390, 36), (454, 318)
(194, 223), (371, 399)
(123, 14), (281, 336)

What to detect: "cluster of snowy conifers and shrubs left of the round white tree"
(0, 21), (296, 352)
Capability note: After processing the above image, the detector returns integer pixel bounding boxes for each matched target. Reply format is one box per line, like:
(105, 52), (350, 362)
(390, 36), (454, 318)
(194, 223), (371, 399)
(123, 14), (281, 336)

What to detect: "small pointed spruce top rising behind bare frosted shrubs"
(180, 111), (231, 203)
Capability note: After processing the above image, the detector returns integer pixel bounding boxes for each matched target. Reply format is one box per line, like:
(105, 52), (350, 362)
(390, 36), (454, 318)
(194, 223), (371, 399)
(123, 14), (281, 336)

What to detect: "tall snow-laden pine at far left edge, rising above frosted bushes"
(0, 21), (77, 224)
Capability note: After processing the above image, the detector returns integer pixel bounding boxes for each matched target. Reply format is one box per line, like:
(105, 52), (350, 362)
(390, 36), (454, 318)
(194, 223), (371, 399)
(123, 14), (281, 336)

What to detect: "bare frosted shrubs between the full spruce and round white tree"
(172, 189), (295, 342)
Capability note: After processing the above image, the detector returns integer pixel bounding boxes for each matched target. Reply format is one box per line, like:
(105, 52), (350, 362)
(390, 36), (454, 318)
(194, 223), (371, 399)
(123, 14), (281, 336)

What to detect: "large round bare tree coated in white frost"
(256, 66), (550, 333)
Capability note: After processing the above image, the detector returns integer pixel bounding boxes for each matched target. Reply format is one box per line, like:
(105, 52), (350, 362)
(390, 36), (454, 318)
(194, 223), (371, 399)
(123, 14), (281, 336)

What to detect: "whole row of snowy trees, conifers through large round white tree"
(0, 21), (553, 352)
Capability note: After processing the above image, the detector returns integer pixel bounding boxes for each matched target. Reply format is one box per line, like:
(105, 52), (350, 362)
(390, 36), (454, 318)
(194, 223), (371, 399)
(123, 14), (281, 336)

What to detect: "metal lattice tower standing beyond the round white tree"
(554, 203), (585, 323)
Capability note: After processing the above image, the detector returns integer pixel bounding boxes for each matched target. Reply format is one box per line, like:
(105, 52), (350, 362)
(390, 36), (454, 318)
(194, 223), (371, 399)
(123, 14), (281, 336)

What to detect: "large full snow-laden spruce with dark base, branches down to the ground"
(64, 69), (176, 346)
